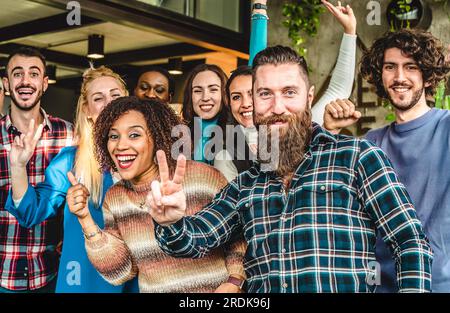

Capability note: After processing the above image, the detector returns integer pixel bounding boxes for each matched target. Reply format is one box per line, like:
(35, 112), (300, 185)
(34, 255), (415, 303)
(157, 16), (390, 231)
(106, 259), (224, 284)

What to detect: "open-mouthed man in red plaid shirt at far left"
(0, 48), (73, 293)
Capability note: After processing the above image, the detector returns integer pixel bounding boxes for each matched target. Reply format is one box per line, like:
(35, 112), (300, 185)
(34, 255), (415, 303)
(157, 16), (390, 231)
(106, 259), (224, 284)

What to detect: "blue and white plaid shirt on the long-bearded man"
(155, 124), (432, 292)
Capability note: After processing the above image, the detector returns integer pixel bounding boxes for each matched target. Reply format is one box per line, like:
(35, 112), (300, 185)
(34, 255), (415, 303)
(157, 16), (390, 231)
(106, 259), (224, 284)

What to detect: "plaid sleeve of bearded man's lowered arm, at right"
(357, 140), (433, 292)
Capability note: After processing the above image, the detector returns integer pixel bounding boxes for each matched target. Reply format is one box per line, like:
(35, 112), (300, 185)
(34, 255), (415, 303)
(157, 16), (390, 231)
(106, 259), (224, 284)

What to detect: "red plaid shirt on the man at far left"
(0, 110), (73, 291)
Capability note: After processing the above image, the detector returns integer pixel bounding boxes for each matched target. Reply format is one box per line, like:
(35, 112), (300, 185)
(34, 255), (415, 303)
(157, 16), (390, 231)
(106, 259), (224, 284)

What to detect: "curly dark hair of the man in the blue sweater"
(360, 29), (450, 99)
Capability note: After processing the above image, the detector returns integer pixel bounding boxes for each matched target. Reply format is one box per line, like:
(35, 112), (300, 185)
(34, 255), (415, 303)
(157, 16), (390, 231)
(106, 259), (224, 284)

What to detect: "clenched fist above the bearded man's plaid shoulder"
(323, 99), (361, 134)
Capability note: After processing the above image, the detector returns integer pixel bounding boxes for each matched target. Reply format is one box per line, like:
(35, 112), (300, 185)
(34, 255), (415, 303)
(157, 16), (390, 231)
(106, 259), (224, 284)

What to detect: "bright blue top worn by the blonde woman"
(5, 147), (138, 293)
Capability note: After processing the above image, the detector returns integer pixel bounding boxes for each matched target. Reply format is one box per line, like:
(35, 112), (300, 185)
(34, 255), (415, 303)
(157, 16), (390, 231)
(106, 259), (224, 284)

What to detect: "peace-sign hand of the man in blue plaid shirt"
(146, 150), (186, 226)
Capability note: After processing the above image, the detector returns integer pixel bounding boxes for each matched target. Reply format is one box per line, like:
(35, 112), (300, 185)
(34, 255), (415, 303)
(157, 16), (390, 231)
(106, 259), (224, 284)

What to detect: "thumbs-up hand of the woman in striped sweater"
(66, 172), (90, 219)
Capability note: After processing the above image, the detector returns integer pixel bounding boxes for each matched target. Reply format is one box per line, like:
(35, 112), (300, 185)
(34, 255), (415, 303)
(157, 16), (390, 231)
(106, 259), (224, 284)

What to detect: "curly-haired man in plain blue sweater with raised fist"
(324, 29), (450, 292)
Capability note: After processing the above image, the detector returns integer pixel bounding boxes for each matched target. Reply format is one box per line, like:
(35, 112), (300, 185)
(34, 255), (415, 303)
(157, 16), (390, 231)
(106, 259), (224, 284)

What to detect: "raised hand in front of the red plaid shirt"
(9, 119), (44, 167)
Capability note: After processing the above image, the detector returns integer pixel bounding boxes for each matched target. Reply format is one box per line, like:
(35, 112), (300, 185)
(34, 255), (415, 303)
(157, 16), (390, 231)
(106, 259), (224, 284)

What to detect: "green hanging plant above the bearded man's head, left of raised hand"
(283, 0), (325, 56)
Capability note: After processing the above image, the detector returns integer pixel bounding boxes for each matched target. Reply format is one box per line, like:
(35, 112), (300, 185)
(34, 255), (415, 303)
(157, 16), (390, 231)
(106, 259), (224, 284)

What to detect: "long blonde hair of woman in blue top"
(74, 66), (128, 207)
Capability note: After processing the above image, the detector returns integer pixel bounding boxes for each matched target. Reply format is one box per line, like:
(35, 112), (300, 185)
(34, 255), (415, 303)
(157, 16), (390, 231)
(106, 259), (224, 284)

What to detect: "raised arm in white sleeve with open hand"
(312, 0), (356, 125)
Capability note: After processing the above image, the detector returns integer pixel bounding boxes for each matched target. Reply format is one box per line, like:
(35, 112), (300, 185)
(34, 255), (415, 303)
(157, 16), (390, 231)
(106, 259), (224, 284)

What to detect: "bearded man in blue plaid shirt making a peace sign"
(147, 46), (432, 292)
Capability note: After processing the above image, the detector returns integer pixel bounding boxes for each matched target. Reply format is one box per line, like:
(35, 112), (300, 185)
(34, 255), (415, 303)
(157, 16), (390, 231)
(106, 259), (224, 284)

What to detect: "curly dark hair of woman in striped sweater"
(93, 97), (184, 173)
